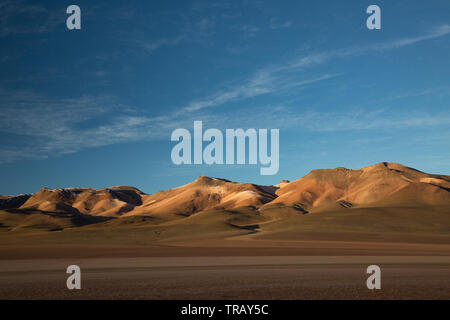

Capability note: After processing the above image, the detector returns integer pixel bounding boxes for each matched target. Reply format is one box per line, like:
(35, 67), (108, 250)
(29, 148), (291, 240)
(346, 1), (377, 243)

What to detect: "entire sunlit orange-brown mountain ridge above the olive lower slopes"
(0, 162), (450, 232)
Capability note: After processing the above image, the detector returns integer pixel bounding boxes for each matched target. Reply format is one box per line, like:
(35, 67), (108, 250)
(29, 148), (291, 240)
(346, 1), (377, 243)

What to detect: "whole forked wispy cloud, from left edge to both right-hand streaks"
(0, 26), (450, 162)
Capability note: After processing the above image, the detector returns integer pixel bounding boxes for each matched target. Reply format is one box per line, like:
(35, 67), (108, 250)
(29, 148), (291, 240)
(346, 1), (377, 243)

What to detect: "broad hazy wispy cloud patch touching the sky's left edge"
(0, 91), (151, 162)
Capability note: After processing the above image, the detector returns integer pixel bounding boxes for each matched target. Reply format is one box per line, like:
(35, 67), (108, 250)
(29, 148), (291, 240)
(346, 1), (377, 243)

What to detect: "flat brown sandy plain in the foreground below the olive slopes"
(0, 241), (450, 299)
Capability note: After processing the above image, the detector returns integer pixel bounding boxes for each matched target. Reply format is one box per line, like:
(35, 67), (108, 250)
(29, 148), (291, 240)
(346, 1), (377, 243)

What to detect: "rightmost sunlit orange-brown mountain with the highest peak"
(270, 162), (450, 210)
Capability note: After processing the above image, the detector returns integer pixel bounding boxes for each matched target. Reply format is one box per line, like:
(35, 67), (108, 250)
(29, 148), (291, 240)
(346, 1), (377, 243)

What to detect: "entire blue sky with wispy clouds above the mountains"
(0, 0), (450, 194)
